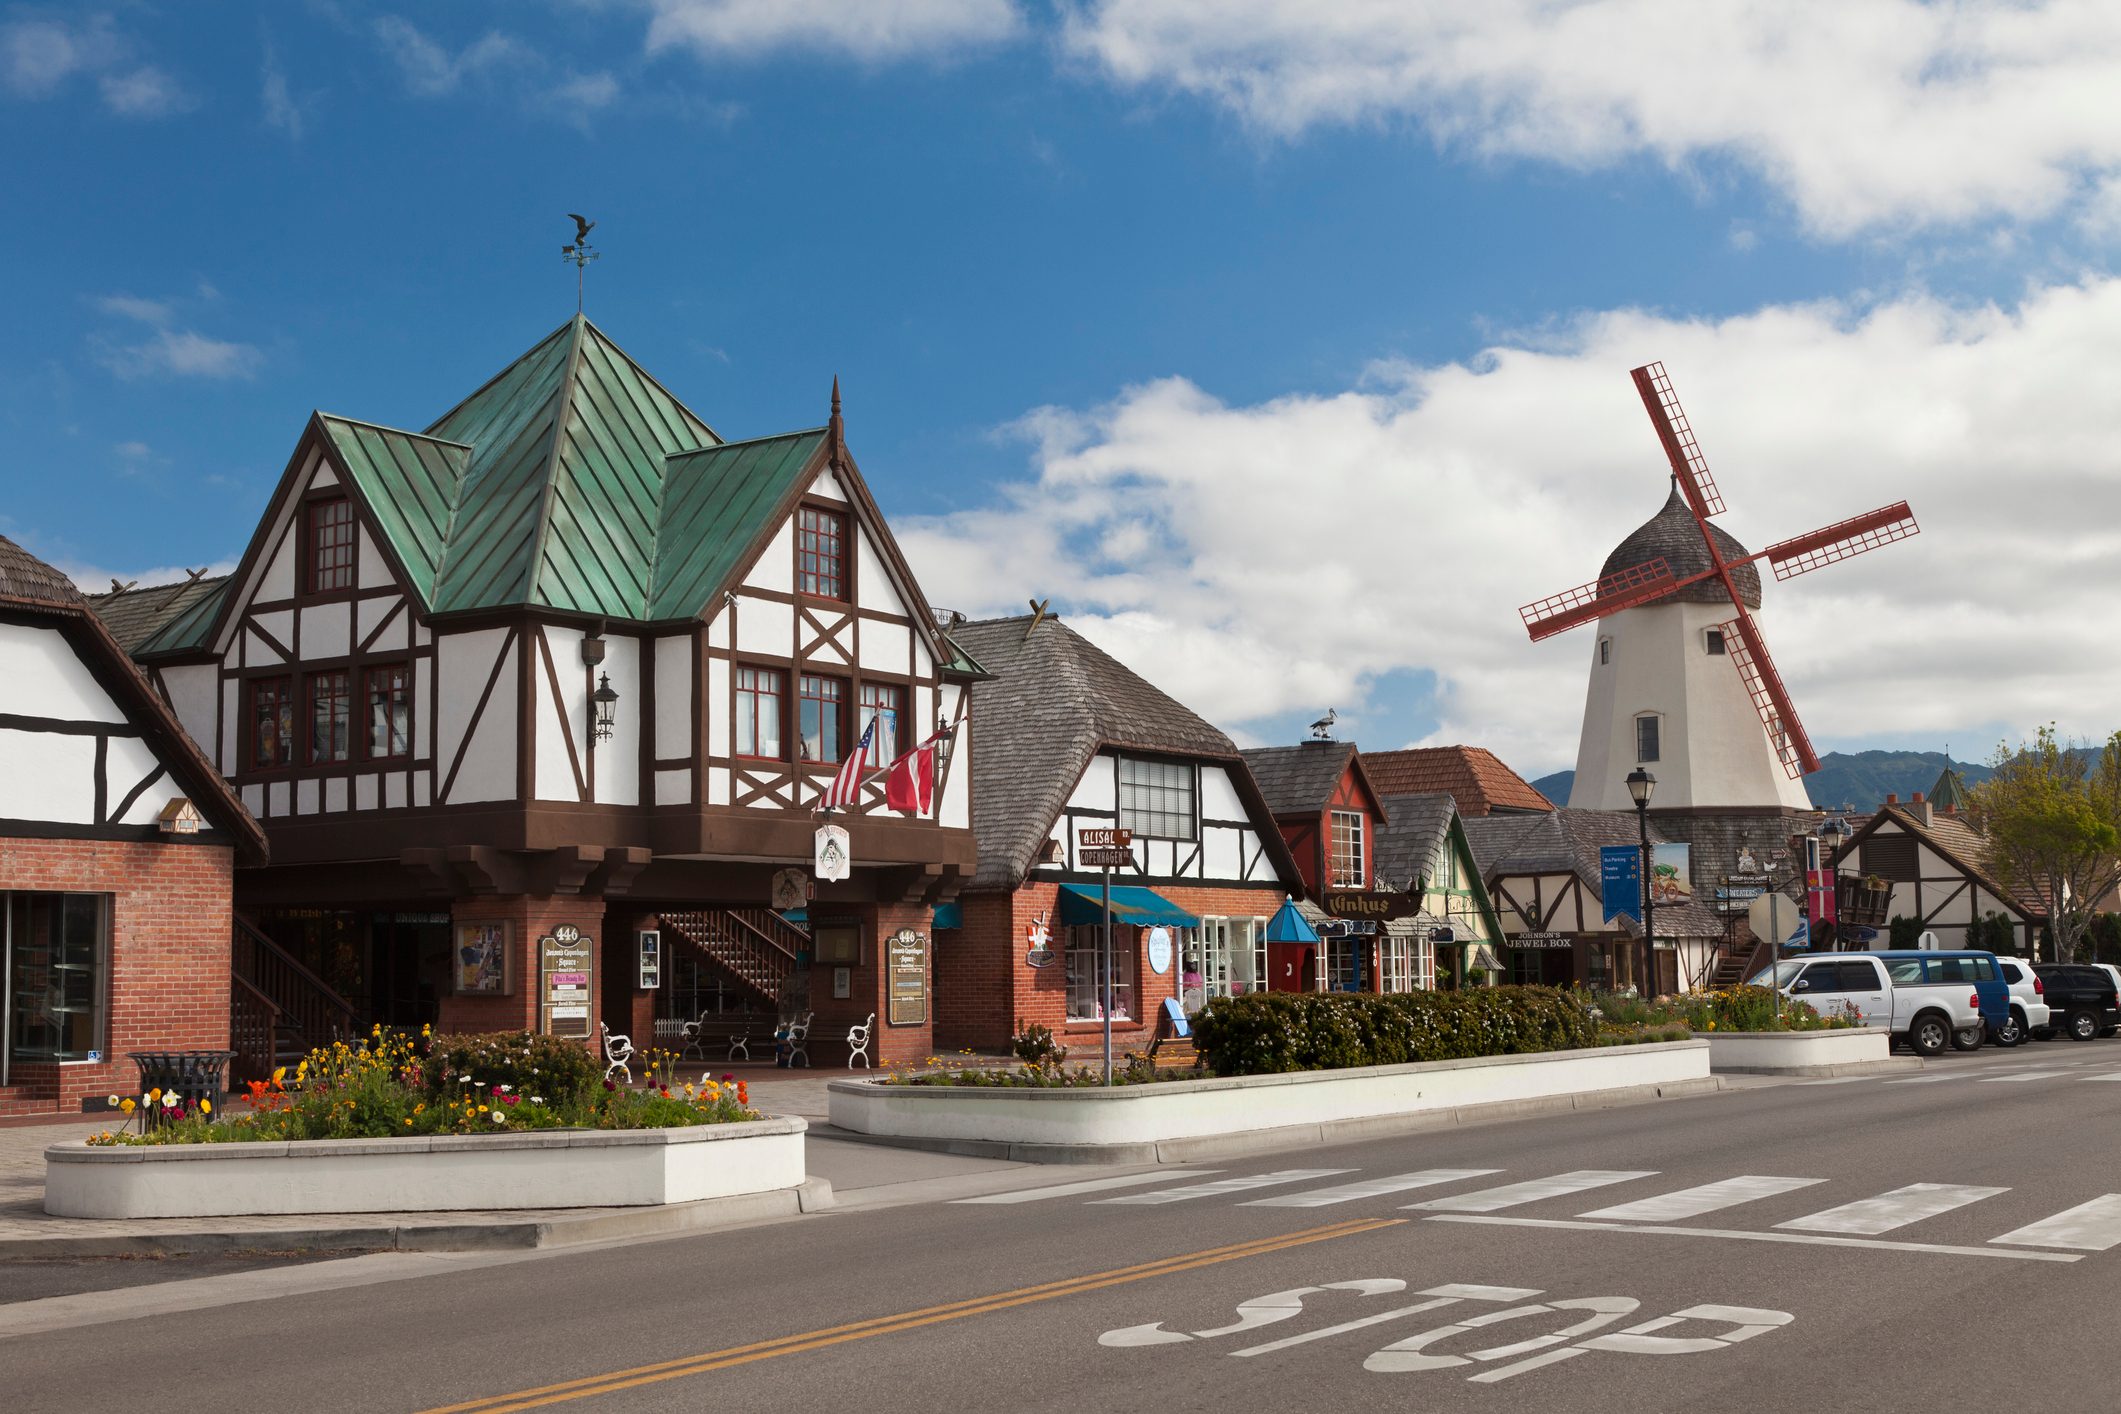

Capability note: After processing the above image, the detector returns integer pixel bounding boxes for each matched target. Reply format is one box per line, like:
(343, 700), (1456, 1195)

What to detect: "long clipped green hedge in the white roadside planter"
(1192, 988), (1597, 1075)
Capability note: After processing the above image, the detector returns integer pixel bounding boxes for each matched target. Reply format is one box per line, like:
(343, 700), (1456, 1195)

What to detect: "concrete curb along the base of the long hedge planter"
(810, 1075), (1726, 1164)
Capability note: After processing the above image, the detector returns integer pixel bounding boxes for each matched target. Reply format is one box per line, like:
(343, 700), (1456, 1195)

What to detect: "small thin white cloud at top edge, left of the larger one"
(645, 0), (1024, 61)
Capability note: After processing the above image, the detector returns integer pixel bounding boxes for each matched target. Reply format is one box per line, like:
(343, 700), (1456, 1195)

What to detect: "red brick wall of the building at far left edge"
(0, 839), (235, 1115)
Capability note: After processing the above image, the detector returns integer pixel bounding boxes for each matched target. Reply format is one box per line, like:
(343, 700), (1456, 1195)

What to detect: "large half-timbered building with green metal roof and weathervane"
(111, 316), (976, 1072)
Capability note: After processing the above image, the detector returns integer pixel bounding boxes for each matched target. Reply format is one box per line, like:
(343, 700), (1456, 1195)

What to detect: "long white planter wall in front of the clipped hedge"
(827, 1041), (1712, 1157)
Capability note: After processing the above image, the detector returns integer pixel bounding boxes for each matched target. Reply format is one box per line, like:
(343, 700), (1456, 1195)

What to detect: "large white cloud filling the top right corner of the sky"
(1063, 0), (2121, 235)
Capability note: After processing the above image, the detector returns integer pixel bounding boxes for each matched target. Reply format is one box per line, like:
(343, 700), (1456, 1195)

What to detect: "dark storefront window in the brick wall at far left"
(0, 892), (110, 1060)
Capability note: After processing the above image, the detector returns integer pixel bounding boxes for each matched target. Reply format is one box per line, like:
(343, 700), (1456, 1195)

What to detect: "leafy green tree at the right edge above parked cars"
(1970, 723), (2121, 962)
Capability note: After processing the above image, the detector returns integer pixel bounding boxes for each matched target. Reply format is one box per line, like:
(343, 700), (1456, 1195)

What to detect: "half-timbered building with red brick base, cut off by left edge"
(0, 538), (265, 1115)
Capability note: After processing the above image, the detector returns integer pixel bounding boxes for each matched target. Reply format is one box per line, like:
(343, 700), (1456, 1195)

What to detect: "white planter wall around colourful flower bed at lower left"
(45, 1119), (808, 1217)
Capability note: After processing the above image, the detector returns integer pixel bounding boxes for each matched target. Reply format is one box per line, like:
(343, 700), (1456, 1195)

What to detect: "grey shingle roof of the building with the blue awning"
(950, 617), (1298, 888)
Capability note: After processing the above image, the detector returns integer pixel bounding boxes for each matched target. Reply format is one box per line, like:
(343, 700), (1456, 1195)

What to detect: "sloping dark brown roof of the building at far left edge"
(0, 536), (265, 863)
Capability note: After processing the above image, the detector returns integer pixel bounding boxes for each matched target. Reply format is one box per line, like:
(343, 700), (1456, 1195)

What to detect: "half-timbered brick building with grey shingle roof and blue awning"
(935, 615), (1302, 1049)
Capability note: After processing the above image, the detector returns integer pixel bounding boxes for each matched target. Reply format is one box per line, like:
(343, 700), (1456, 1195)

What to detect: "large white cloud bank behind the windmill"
(901, 280), (2121, 776)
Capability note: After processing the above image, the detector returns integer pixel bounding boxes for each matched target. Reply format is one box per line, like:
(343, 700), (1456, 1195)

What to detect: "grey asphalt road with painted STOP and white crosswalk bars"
(0, 1041), (2121, 1414)
